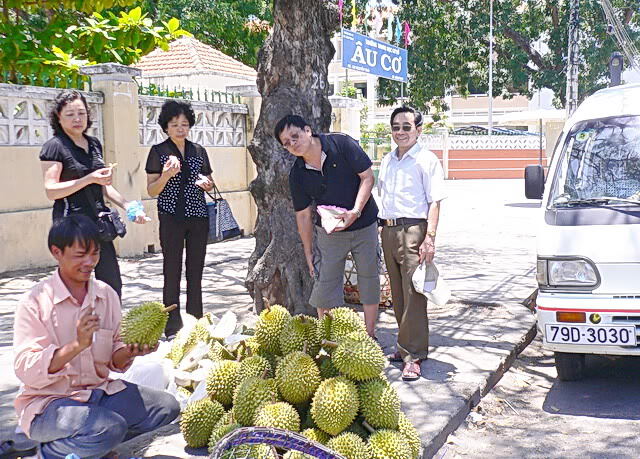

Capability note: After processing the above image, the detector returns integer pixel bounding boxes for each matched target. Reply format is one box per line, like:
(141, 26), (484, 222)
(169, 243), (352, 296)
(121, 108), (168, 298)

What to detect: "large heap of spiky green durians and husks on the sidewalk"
(167, 305), (421, 459)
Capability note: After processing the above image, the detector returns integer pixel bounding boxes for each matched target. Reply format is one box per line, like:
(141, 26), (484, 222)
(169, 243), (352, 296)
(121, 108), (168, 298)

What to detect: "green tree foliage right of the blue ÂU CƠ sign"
(379, 0), (640, 109)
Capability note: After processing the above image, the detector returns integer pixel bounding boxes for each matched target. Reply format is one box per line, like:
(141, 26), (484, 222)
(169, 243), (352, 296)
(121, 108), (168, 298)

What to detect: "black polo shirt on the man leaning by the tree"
(289, 133), (378, 231)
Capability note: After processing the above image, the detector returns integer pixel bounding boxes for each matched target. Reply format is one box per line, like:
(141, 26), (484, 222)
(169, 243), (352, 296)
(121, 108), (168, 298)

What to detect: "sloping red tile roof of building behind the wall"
(135, 37), (257, 78)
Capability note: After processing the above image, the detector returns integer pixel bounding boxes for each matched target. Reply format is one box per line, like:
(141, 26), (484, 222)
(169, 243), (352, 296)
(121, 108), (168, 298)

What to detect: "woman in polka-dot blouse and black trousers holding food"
(145, 100), (213, 338)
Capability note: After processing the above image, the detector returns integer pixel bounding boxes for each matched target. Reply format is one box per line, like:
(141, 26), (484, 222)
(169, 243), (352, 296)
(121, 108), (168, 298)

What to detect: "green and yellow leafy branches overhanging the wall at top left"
(0, 0), (188, 85)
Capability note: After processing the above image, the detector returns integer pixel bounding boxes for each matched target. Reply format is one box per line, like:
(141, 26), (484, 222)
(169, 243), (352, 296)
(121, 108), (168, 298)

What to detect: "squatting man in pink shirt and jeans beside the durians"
(13, 215), (180, 459)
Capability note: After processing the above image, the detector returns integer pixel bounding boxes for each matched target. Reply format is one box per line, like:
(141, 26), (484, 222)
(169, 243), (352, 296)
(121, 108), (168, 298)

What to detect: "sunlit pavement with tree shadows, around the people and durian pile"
(0, 180), (538, 458)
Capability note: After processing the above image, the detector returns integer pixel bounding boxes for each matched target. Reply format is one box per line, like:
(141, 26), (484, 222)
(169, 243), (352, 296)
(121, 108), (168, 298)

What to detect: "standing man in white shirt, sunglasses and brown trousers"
(378, 107), (446, 381)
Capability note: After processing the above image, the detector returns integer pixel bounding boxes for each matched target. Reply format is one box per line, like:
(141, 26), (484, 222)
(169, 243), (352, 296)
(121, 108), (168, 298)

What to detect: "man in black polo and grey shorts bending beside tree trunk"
(274, 115), (380, 337)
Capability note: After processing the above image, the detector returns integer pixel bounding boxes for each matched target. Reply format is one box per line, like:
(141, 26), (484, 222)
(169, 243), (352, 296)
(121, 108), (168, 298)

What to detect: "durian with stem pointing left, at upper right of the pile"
(324, 332), (387, 381)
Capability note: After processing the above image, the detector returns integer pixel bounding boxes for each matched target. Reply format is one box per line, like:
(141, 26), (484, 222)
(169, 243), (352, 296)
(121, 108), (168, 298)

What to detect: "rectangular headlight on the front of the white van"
(536, 257), (600, 288)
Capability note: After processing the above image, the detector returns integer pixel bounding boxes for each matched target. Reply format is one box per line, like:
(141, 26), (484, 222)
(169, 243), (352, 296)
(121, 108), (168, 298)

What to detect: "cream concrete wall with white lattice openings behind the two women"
(0, 64), (259, 273)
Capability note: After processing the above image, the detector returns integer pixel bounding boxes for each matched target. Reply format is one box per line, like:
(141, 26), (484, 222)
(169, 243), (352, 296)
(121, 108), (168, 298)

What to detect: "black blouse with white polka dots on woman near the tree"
(145, 138), (212, 218)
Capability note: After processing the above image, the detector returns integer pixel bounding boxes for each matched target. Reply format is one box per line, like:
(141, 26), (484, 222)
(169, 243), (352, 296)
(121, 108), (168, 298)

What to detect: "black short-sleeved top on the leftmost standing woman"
(40, 133), (109, 220)
